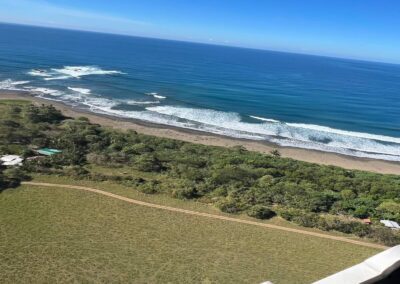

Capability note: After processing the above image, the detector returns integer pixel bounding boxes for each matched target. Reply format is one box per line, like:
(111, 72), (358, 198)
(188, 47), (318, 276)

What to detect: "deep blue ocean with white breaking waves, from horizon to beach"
(0, 24), (400, 161)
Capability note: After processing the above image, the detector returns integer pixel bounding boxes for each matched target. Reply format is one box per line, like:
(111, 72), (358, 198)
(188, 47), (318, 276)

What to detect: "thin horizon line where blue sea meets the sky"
(0, 20), (400, 66)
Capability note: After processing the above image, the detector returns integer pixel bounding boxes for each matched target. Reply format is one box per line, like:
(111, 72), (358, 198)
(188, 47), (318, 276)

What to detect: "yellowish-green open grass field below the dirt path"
(0, 186), (378, 283)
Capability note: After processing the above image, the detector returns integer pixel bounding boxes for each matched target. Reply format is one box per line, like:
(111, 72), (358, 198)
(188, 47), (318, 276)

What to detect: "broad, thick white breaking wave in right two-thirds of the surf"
(147, 106), (400, 161)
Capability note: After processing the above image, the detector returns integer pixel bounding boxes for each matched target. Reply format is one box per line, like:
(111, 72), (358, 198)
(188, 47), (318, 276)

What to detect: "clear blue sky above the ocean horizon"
(0, 0), (400, 63)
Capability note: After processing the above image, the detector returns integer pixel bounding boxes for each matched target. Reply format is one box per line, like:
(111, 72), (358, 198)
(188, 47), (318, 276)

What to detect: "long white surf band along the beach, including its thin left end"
(21, 91), (400, 161)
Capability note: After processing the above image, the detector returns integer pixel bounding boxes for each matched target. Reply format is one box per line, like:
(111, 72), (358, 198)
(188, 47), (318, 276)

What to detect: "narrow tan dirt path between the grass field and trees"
(22, 182), (388, 249)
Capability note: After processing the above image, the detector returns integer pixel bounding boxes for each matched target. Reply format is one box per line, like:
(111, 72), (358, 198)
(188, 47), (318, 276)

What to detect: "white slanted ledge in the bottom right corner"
(314, 246), (400, 284)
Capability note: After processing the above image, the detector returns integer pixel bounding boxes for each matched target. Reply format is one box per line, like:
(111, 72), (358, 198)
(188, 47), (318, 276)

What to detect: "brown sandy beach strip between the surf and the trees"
(0, 91), (400, 175)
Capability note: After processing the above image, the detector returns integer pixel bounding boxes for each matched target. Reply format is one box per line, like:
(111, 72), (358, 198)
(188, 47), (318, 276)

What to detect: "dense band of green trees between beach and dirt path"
(0, 101), (400, 243)
